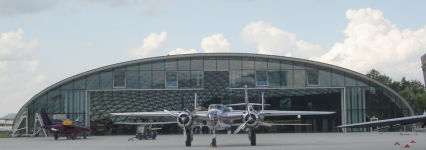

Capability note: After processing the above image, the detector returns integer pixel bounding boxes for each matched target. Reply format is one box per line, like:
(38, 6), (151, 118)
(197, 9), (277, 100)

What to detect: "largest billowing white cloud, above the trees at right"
(311, 8), (426, 81)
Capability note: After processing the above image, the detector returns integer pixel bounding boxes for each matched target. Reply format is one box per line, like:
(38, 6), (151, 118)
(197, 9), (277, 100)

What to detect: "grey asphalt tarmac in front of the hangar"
(0, 132), (426, 150)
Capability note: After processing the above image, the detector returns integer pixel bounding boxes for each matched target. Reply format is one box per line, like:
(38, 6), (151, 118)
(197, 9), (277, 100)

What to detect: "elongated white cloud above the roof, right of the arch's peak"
(240, 21), (324, 58)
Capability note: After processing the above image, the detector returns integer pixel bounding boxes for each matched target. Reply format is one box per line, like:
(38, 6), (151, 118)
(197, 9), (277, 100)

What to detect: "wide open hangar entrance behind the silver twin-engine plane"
(88, 87), (343, 134)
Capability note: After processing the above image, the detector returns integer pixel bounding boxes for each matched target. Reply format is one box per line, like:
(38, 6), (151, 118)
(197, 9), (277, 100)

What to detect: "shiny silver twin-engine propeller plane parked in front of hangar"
(110, 85), (335, 147)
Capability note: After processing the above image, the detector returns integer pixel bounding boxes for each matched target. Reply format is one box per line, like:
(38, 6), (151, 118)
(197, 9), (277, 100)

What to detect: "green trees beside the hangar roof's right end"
(366, 69), (426, 114)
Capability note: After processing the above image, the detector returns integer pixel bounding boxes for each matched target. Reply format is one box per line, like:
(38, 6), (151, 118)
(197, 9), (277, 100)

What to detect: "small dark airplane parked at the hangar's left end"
(41, 109), (90, 140)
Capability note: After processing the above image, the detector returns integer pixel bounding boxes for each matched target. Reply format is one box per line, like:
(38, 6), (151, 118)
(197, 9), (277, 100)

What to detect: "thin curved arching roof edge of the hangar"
(17, 53), (414, 117)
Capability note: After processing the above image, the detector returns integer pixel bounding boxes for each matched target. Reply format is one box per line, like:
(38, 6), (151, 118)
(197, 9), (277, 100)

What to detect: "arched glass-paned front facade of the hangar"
(15, 54), (413, 135)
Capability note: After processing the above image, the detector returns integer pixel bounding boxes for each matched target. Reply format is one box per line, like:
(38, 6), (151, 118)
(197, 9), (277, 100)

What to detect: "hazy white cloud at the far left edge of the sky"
(0, 29), (48, 115)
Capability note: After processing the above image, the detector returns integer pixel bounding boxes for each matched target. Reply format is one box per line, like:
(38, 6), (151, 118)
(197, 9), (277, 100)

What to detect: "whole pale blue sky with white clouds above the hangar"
(0, 0), (426, 117)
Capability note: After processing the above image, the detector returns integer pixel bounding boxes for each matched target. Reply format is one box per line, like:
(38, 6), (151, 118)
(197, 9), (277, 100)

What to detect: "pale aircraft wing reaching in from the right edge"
(337, 115), (426, 128)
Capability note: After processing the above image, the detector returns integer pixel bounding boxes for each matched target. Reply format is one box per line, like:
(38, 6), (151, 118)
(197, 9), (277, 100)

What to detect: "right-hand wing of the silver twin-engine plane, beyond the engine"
(259, 110), (336, 116)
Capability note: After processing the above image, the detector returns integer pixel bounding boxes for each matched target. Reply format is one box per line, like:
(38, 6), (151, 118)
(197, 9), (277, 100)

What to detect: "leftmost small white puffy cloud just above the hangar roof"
(128, 31), (167, 58)
